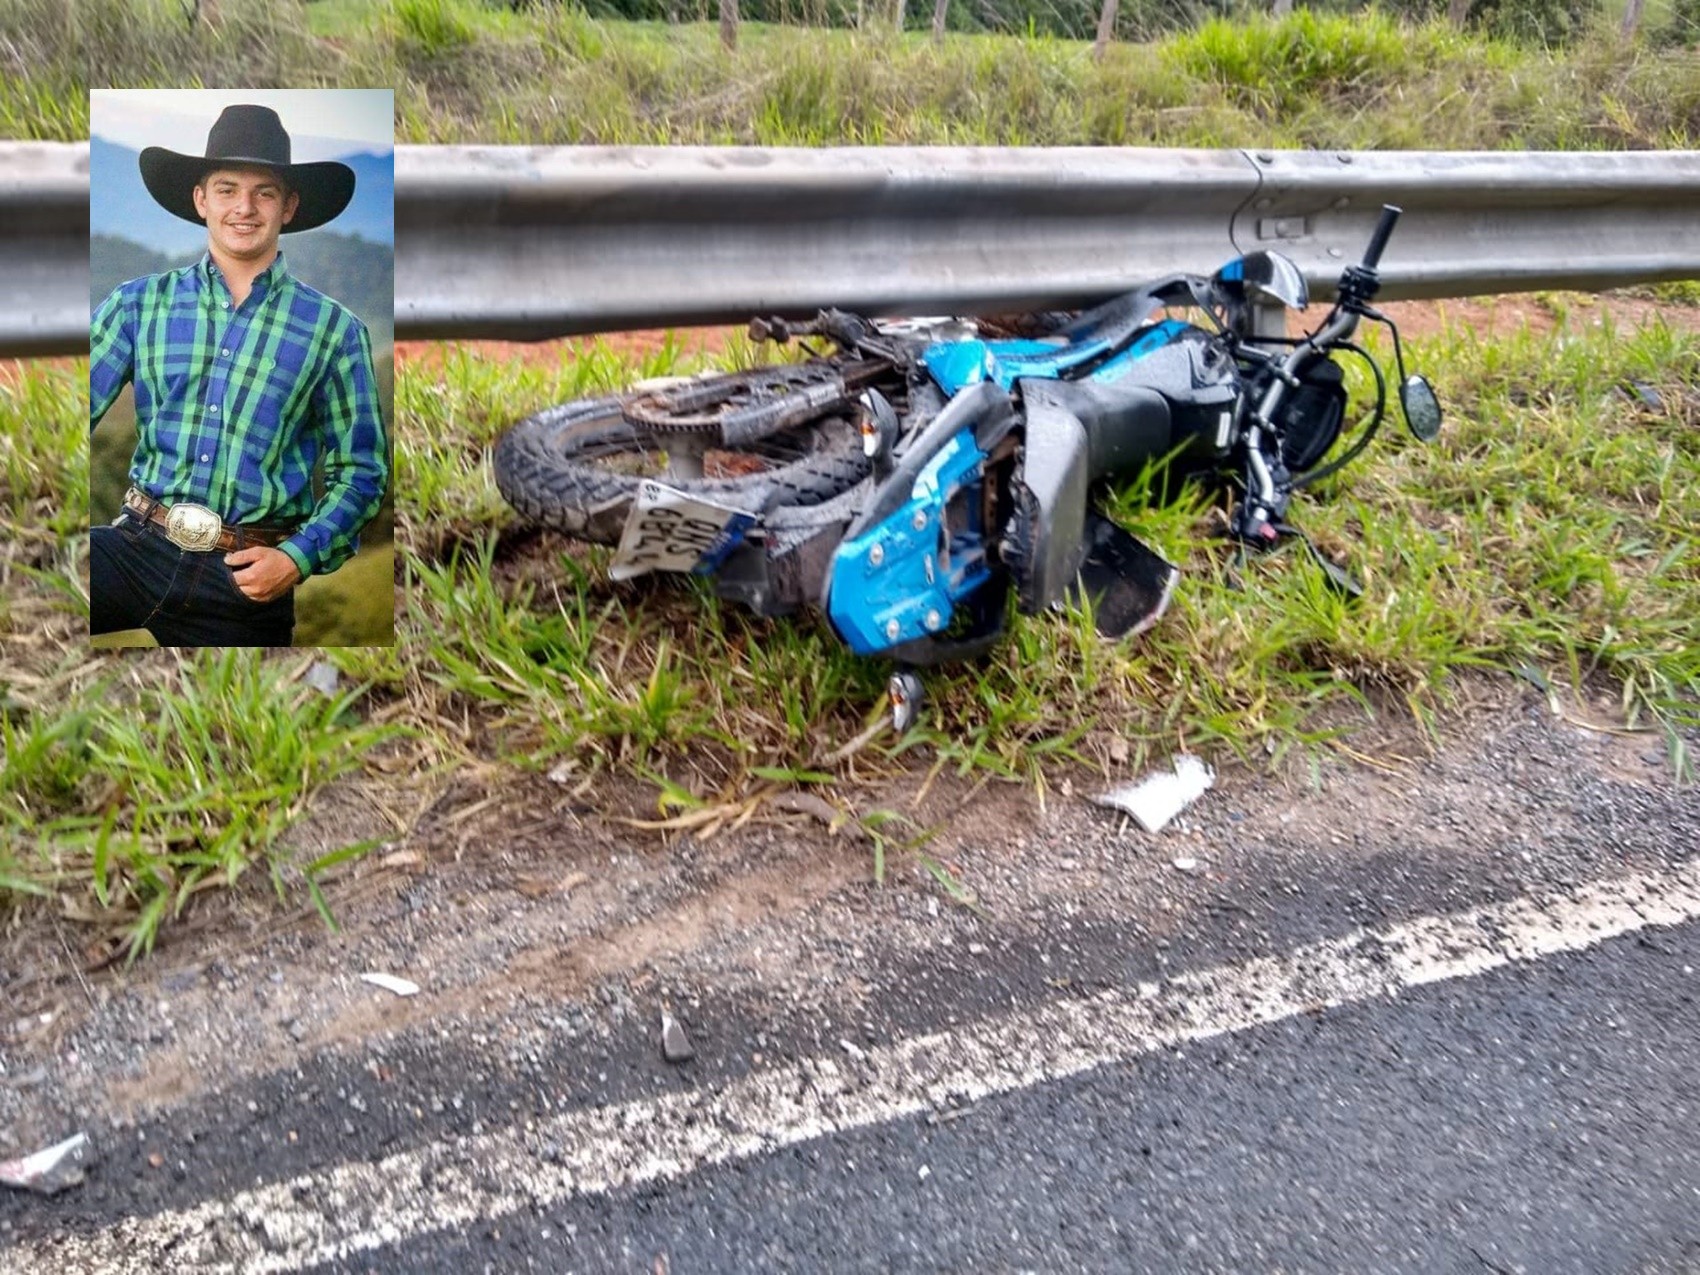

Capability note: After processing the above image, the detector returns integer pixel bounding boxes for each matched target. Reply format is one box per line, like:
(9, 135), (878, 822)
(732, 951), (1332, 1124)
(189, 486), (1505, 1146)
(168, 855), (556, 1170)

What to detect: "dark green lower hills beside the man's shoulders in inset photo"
(88, 232), (396, 349)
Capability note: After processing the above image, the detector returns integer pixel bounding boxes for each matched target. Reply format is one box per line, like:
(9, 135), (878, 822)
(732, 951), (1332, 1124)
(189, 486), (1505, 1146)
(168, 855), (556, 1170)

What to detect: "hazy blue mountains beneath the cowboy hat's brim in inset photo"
(88, 138), (396, 260)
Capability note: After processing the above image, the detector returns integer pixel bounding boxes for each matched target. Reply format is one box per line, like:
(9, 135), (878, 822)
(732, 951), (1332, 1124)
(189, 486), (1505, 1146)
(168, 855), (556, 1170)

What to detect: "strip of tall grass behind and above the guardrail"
(0, 0), (1700, 150)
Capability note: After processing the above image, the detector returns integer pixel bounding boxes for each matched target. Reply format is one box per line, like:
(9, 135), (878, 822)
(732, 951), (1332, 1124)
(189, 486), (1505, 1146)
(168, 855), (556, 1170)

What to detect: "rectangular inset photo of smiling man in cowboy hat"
(88, 88), (396, 648)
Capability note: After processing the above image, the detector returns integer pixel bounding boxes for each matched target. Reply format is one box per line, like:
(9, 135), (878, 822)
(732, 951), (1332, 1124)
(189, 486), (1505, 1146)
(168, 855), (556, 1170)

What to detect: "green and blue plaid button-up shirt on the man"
(88, 253), (389, 578)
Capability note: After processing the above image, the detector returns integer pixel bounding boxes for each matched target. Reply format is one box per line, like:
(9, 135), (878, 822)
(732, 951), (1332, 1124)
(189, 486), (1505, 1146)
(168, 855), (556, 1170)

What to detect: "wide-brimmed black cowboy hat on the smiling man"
(139, 105), (354, 235)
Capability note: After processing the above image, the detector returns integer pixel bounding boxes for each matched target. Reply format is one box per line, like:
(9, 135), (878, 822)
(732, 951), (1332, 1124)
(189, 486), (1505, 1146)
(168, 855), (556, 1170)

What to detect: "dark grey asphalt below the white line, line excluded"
(345, 923), (1700, 1275)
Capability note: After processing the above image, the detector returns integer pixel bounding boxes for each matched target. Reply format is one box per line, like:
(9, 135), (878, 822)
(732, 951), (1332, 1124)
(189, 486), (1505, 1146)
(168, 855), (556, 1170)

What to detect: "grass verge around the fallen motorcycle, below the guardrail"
(0, 298), (1700, 950)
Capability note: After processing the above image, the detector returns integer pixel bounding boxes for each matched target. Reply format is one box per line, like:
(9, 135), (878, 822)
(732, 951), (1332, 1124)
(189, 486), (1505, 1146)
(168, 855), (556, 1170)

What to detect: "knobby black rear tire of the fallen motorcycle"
(493, 396), (869, 544)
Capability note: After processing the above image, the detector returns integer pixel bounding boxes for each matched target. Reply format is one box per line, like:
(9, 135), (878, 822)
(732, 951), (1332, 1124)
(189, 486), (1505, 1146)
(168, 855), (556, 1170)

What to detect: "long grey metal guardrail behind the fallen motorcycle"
(0, 145), (1700, 354)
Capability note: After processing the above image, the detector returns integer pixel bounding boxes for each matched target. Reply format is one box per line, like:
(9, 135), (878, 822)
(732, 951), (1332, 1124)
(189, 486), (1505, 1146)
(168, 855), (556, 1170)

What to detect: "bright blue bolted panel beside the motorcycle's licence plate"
(826, 428), (991, 655)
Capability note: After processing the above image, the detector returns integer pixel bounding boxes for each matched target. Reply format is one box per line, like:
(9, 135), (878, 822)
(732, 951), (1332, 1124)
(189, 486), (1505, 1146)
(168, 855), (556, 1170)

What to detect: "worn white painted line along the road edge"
(0, 862), (1700, 1275)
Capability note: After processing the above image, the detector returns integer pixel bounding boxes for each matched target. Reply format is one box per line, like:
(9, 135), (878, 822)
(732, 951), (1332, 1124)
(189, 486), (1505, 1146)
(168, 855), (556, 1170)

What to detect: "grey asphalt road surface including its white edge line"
(0, 862), (1700, 1273)
